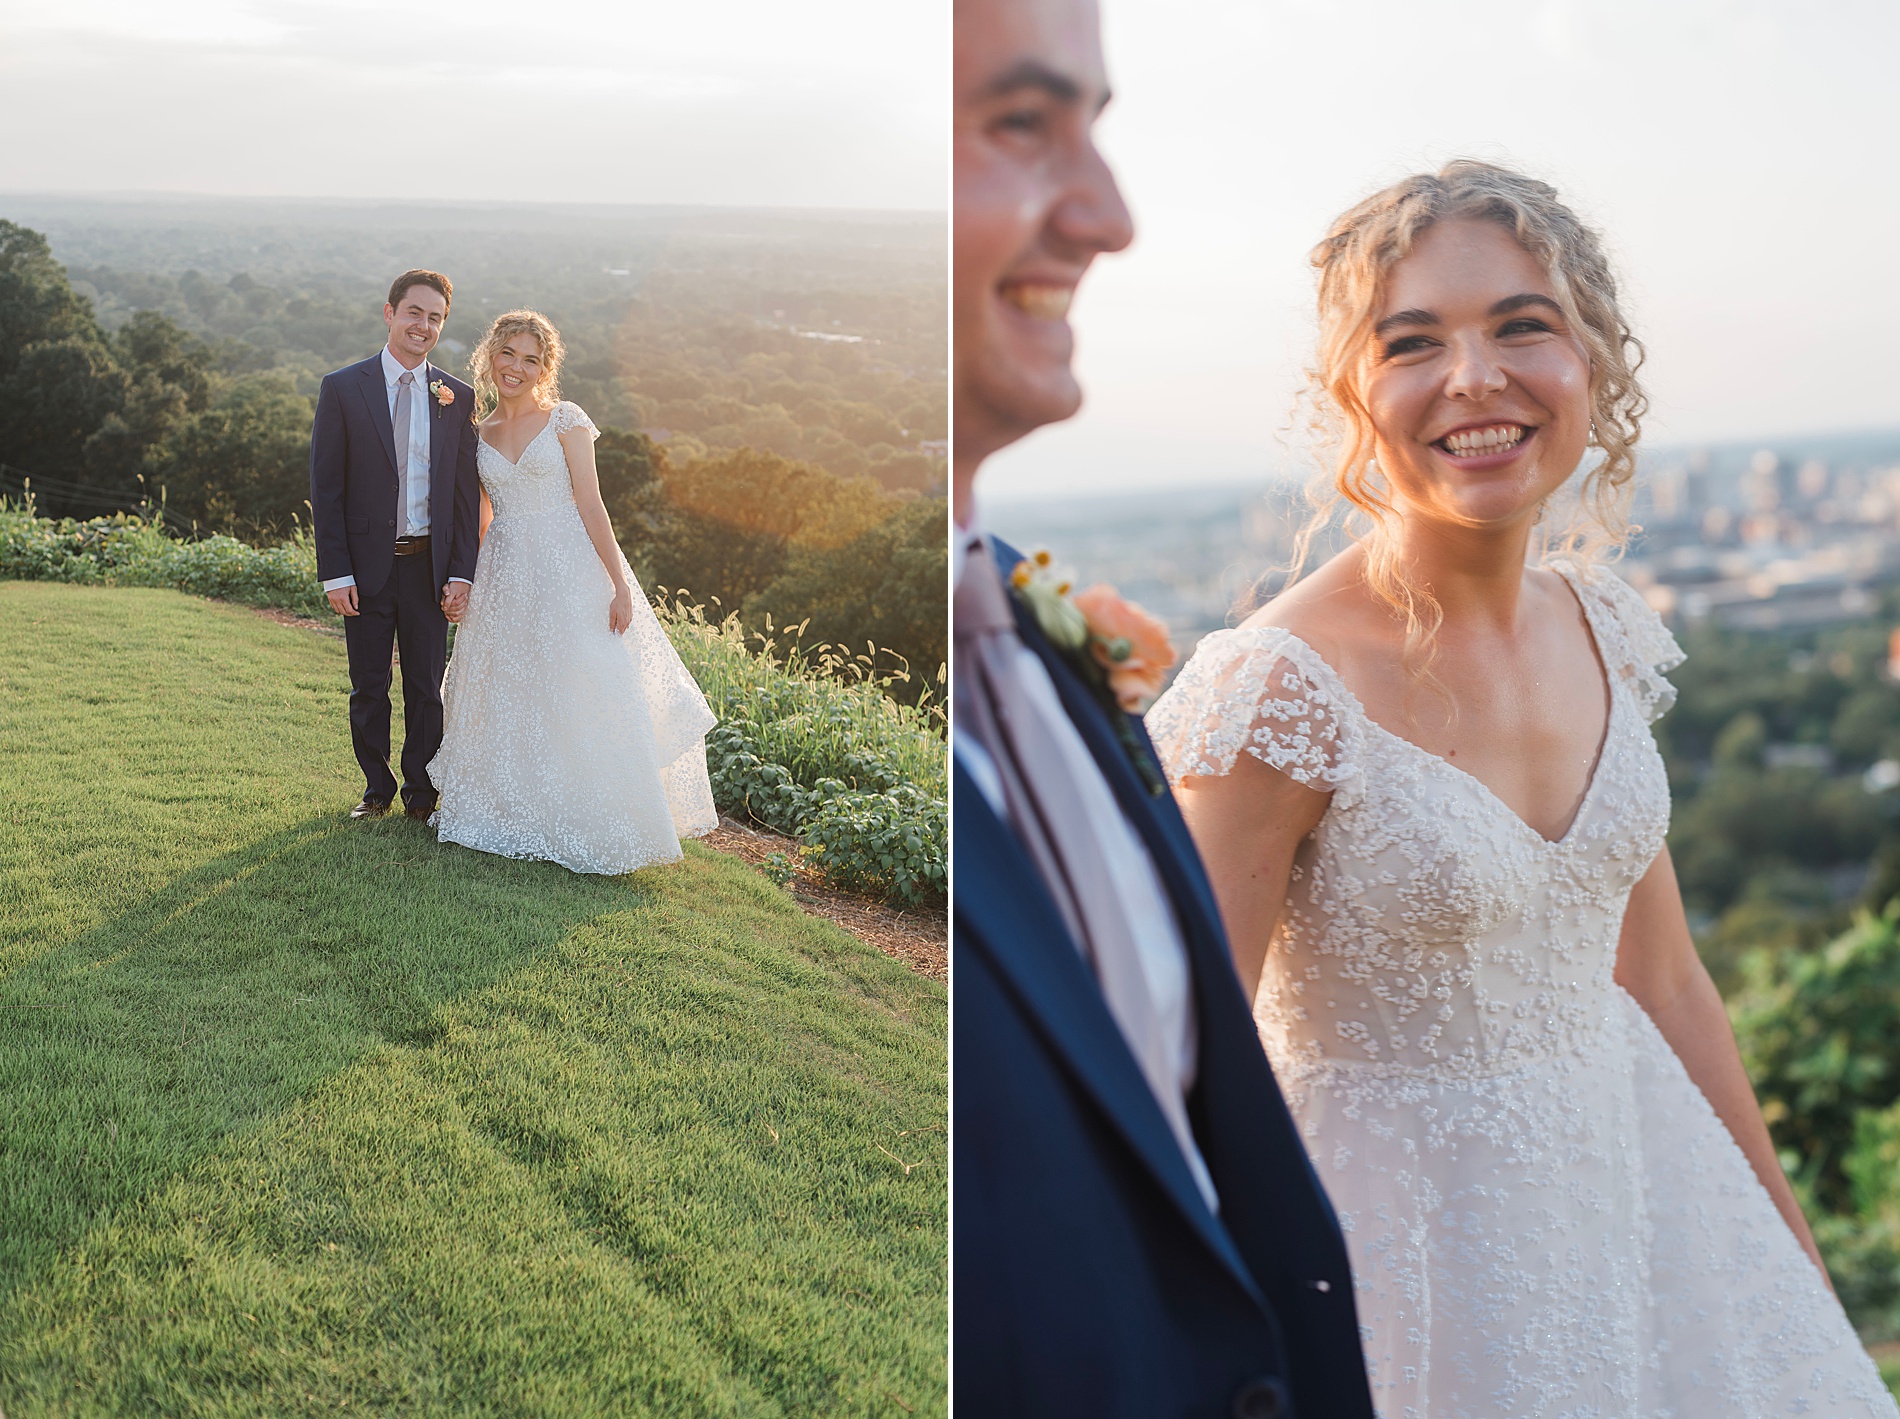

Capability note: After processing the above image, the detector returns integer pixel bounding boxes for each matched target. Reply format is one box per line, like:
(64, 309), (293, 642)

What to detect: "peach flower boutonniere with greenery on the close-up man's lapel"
(1009, 551), (1174, 798)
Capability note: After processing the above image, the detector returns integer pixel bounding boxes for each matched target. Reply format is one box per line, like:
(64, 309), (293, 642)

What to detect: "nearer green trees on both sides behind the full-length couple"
(0, 220), (946, 699)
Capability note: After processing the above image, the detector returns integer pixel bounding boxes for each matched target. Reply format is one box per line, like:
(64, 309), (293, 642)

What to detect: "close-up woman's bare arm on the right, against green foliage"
(1617, 847), (1834, 1286)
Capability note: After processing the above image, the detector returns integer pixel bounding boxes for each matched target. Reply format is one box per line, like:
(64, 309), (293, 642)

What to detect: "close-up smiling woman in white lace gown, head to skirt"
(1148, 161), (1896, 1419)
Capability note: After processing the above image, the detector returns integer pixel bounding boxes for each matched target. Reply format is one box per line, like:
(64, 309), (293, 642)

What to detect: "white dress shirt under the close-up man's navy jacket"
(952, 520), (1220, 1212)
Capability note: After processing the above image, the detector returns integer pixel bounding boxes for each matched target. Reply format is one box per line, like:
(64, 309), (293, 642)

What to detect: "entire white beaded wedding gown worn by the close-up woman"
(1148, 568), (1896, 1419)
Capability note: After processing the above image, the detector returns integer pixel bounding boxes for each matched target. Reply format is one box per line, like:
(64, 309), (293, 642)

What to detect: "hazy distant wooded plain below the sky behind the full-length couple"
(59, 203), (948, 494)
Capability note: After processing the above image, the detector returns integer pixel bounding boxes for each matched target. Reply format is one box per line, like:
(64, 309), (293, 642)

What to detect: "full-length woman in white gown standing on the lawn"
(429, 310), (718, 872)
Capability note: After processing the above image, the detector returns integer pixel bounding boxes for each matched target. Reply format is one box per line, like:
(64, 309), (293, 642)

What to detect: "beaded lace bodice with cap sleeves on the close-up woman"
(1148, 574), (1682, 1075)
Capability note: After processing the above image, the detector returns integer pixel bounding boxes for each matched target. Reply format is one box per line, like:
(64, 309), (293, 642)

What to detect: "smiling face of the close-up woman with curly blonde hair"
(1359, 218), (1590, 526)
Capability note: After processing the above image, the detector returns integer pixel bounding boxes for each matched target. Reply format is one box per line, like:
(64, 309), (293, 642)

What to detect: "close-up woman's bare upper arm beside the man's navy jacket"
(1178, 752), (1332, 1003)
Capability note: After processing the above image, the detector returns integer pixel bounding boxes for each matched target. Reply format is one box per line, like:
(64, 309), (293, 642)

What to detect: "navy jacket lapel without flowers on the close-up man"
(954, 764), (1260, 1299)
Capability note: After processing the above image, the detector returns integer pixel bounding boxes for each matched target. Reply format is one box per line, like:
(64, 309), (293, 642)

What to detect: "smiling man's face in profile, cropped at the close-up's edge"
(954, 0), (1134, 475)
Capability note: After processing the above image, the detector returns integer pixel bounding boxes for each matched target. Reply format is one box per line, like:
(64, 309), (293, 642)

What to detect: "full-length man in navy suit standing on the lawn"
(310, 270), (479, 821)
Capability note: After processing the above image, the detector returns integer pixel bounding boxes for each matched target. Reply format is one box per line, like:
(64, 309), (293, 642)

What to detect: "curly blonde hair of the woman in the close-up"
(1294, 158), (1649, 676)
